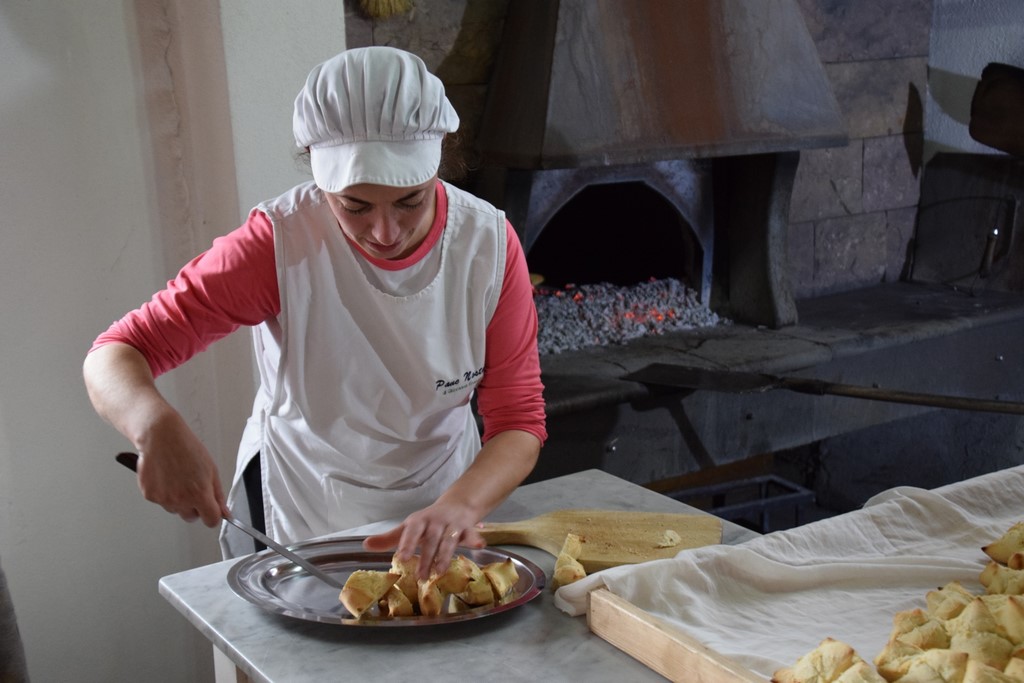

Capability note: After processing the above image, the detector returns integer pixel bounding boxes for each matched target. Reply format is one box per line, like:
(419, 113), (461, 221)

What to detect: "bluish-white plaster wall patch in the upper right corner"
(925, 0), (1024, 161)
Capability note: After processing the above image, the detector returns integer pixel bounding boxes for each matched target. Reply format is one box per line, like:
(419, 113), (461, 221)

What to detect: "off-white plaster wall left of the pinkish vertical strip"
(0, 0), (207, 681)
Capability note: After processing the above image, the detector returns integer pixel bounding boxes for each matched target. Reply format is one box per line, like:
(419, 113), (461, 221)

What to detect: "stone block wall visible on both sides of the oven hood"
(345, 0), (932, 298)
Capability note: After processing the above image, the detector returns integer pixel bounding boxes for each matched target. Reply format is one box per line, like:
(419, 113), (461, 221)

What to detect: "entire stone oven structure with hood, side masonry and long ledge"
(346, 0), (1024, 528)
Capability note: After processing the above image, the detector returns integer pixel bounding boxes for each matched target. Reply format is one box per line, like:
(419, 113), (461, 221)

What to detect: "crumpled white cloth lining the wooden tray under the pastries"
(555, 467), (1024, 677)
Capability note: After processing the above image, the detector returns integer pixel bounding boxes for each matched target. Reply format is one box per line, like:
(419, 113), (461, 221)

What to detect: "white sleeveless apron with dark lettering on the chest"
(221, 182), (506, 557)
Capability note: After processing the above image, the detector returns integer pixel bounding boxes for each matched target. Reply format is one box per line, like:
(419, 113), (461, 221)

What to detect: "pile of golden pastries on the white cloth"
(772, 522), (1024, 683)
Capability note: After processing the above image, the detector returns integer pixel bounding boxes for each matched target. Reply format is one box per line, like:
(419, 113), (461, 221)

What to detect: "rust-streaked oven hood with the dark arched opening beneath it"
(477, 0), (846, 328)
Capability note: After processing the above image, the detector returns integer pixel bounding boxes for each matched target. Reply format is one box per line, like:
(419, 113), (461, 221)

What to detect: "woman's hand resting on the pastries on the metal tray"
(362, 501), (487, 580)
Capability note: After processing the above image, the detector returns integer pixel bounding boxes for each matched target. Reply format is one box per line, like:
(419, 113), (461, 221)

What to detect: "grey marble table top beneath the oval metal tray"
(160, 470), (758, 683)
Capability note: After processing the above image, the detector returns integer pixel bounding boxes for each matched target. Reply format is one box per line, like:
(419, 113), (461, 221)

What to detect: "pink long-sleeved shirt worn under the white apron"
(90, 183), (547, 443)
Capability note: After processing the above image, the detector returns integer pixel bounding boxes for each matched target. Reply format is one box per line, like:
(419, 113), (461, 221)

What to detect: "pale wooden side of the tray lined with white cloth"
(587, 588), (765, 683)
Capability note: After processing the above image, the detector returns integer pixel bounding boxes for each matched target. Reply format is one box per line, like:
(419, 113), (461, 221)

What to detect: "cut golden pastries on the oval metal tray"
(339, 555), (519, 618)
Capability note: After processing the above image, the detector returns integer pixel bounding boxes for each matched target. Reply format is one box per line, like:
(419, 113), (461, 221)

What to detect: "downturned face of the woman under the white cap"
(325, 178), (436, 260)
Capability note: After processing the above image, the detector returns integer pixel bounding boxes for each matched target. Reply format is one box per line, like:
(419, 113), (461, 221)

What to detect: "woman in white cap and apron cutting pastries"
(84, 47), (547, 575)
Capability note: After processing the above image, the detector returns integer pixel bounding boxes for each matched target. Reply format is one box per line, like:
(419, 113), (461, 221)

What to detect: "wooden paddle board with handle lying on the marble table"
(480, 509), (722, 573)
